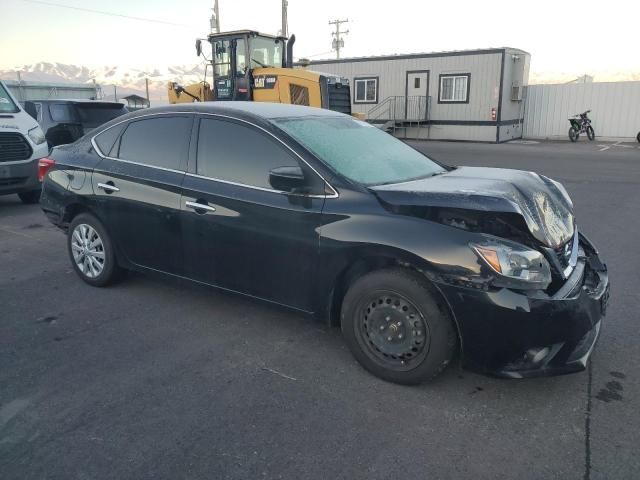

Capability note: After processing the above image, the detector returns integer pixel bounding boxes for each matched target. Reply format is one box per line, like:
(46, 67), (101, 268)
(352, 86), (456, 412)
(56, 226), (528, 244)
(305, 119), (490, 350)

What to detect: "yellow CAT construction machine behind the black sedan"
(168, 30), (351, 114)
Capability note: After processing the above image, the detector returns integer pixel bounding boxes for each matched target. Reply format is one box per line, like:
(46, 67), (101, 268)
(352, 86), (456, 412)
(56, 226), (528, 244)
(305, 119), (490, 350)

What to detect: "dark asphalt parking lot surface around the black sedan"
(0, 141), (640, 480)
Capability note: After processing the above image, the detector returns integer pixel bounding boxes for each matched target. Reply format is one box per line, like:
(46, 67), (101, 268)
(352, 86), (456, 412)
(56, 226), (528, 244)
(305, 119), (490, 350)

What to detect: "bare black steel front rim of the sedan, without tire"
(357, 292), (429, 371)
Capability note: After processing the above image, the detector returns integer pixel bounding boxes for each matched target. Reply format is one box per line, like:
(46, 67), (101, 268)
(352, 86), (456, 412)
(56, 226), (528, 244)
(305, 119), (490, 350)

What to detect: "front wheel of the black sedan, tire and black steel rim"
(340, 268), (457, 385)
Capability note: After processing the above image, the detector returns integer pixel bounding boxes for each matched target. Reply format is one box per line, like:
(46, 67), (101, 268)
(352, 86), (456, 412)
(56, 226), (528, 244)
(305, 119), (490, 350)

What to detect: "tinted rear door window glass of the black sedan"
(118, 115), (192, 170)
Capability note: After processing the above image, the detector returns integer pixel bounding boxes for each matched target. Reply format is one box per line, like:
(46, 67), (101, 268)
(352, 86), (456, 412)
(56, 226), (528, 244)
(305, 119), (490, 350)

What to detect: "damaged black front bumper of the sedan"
(438, 234), (610, 378)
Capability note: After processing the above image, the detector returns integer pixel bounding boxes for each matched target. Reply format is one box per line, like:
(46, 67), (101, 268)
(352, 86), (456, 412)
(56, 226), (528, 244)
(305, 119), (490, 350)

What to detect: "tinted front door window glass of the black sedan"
(197, 118), (300, 190)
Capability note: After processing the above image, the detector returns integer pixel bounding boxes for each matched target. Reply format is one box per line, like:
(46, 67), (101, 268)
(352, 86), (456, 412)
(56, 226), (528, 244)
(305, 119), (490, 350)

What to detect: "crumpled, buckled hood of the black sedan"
(370, 167), (574, 248)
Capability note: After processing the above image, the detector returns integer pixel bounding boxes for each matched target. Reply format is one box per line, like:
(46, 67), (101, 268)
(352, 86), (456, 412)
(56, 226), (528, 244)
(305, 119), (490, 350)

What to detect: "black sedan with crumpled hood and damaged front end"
(40, 102), (609, 384)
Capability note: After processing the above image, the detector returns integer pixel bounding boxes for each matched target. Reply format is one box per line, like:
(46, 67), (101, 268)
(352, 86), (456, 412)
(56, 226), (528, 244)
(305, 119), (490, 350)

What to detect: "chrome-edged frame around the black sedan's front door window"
(187, 112), (339, 198)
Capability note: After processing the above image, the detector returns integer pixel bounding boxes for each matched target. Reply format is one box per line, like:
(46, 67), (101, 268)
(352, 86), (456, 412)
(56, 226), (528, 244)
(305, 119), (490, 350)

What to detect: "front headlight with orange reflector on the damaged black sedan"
(471, 240), (551, 290)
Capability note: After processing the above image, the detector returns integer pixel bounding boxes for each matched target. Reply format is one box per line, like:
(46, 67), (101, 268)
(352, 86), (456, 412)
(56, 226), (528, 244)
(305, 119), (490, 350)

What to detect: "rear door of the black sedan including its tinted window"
(92, 114), (193, 275)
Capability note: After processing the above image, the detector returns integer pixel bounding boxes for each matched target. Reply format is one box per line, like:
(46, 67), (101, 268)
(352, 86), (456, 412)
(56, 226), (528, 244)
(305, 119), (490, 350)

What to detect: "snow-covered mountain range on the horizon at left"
(0, 62), (204, 104)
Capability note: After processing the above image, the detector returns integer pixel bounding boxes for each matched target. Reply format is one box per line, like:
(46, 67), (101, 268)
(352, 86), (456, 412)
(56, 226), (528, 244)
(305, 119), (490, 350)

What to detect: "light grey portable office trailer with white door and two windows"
(298, 48), (531, 142)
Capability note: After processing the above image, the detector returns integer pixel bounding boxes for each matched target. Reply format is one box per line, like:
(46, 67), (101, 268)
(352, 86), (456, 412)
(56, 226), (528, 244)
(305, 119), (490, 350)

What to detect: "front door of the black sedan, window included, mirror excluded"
(182, 116), (324, 310)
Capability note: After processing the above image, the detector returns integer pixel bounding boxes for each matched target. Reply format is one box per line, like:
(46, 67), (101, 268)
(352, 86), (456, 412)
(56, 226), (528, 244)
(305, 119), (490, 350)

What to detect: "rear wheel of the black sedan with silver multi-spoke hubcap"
(67, 213), (122, 287)
